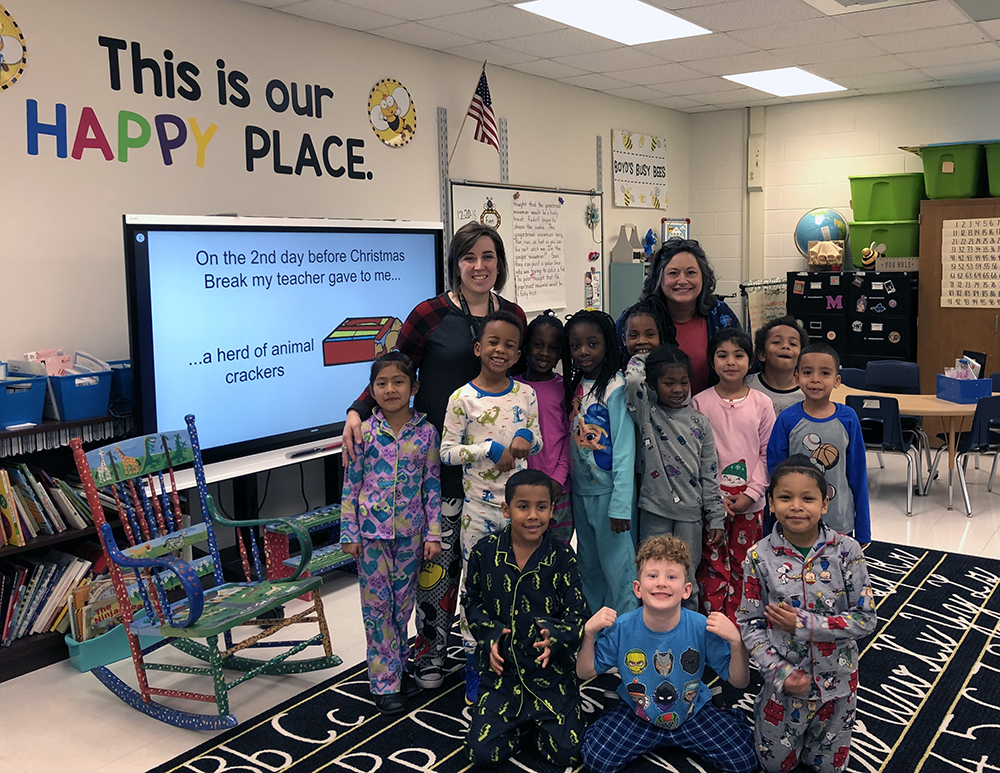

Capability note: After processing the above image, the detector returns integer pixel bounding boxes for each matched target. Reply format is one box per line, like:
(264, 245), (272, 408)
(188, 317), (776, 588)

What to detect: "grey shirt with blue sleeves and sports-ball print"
(767, 403), (872, 545)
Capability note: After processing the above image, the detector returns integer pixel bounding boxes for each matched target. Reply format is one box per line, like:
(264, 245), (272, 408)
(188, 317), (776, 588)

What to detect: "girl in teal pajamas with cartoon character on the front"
(563, 311), (638, 614)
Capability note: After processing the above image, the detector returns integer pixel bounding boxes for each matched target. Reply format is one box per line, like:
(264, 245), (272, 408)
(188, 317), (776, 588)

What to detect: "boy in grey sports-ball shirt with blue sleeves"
(765, 343), (872, 545)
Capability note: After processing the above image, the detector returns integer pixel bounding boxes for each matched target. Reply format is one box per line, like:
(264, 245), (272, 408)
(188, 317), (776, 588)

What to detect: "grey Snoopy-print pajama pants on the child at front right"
(754, 683), (857, 773)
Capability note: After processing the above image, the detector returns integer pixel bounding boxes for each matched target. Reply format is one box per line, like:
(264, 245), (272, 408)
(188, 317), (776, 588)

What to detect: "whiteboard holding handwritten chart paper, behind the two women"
(450, 180), (605, 319)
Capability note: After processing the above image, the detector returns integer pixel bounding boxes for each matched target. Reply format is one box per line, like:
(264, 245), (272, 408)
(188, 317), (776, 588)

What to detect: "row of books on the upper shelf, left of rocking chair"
(0, 464), (100, 547)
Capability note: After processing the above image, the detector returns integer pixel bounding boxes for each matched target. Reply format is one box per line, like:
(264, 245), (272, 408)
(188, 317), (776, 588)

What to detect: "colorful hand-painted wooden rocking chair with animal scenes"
(70, 415), (341, 730)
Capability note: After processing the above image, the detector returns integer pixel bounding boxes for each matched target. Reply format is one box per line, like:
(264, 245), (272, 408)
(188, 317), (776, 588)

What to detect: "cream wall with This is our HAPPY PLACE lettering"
(0, 0), (690, 359)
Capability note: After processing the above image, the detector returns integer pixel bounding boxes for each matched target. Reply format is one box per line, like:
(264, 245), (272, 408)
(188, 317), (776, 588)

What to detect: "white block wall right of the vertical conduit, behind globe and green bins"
(764, 84), (1000, 277)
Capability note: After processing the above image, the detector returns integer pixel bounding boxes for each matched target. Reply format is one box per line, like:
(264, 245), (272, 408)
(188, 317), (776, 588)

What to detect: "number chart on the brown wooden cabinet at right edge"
(941, 218), (1000, 308)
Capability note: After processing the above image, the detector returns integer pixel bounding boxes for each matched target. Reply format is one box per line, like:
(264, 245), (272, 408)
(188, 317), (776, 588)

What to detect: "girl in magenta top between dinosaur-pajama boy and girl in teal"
(515, 309), (573, 546)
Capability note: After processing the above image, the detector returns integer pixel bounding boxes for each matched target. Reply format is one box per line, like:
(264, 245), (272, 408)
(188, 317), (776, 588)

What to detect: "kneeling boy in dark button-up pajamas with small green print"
(463, 470), (587, 767)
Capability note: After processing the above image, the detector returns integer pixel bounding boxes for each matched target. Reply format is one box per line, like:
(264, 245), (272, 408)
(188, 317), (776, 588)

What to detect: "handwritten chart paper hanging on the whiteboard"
(513, 193), (566, 310)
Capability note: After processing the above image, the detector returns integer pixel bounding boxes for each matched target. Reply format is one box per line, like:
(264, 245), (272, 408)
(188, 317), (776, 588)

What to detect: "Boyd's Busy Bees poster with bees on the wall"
(611, 129), (667, 209)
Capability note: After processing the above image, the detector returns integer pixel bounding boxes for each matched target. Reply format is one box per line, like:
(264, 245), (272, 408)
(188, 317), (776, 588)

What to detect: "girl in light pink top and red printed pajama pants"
(692, 328), (774, 622)
